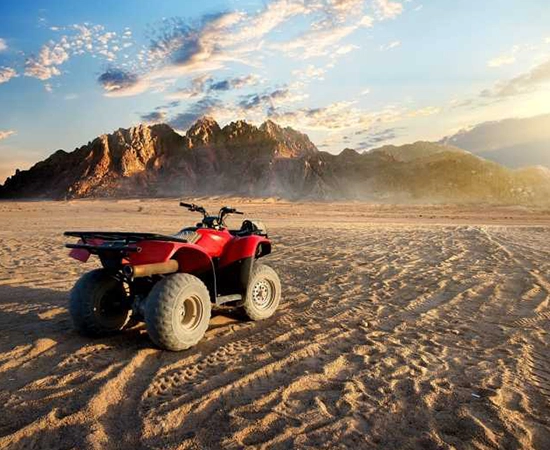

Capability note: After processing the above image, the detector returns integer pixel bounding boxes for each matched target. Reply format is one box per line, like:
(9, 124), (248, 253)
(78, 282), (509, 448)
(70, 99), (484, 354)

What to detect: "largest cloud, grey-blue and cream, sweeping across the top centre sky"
(97, 0), (392, 99)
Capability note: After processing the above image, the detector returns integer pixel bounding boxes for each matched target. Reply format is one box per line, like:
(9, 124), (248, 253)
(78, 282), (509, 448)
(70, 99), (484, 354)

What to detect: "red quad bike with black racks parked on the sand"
(65, 203), (281, 351)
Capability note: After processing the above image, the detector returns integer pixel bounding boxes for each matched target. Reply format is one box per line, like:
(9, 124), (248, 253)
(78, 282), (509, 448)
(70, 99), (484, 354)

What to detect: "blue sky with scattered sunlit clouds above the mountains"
(0, 0), (550, 183)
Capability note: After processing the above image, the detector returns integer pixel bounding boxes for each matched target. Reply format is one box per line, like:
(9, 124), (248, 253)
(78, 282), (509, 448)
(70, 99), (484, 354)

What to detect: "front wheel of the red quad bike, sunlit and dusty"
(242, 264), (281, 320)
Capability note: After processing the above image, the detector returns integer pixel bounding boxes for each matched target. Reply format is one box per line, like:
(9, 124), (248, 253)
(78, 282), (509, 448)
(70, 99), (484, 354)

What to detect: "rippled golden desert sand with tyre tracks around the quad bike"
(0, 199), (550, 450)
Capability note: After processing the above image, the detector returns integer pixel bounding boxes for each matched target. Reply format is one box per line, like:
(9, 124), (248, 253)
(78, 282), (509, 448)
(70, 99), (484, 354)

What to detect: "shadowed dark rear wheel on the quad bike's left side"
(69, 269), (130, 337)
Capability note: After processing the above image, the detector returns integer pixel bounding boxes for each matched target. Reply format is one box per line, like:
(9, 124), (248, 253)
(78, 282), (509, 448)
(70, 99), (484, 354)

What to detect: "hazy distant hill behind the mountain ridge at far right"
(441, 114), (550, 168)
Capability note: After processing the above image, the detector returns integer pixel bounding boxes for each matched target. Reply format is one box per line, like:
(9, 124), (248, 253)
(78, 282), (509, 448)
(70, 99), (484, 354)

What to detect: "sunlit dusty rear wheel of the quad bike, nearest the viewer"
(145, 273), (212, 351)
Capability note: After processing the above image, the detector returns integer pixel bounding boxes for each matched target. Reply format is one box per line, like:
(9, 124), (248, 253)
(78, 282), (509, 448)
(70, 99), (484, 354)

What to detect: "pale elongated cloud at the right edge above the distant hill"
(480, 59), (550, 99)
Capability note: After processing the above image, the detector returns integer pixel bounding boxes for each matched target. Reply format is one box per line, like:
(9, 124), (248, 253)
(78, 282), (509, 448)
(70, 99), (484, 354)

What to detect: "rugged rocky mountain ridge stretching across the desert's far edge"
(0, 117), (550, 204)
